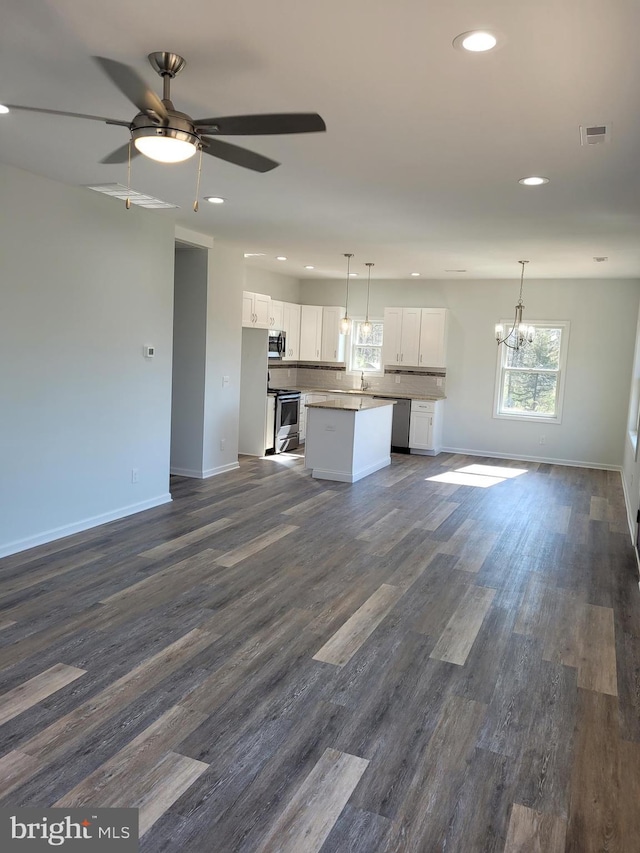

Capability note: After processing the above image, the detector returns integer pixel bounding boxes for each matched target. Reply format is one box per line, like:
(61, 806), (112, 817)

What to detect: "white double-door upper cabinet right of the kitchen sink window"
(382, 308), (448, 367)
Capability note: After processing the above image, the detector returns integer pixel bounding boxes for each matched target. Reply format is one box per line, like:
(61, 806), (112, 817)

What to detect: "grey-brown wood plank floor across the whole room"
(0, 454), (640, 853)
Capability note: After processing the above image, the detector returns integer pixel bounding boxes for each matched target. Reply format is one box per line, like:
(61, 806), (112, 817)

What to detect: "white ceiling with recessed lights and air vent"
(0, 0), (640, 279)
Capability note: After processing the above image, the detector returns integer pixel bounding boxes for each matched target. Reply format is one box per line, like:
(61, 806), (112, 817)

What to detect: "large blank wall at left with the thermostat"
(0, 165), (174, 555)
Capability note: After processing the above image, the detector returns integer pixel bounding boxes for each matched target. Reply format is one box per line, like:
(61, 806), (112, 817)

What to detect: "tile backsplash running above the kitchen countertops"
(269, 362), (447, 397)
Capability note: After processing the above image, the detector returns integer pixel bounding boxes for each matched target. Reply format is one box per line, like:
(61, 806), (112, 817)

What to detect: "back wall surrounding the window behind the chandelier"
(301, 276), (640, 467)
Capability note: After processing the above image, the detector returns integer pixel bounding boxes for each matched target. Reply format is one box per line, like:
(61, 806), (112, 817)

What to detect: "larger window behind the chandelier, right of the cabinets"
(494, 322), (569, 423)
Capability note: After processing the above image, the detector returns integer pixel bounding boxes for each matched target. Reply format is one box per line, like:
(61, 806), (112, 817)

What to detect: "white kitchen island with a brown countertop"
(304, 397), (395, 483)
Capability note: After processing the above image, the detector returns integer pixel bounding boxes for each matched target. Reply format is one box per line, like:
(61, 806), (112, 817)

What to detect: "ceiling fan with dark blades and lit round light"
(7, 51), (326, 172)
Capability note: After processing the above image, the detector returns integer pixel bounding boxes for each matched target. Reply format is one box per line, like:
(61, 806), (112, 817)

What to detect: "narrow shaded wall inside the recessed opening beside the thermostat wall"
(171, 249), (208, 477)
